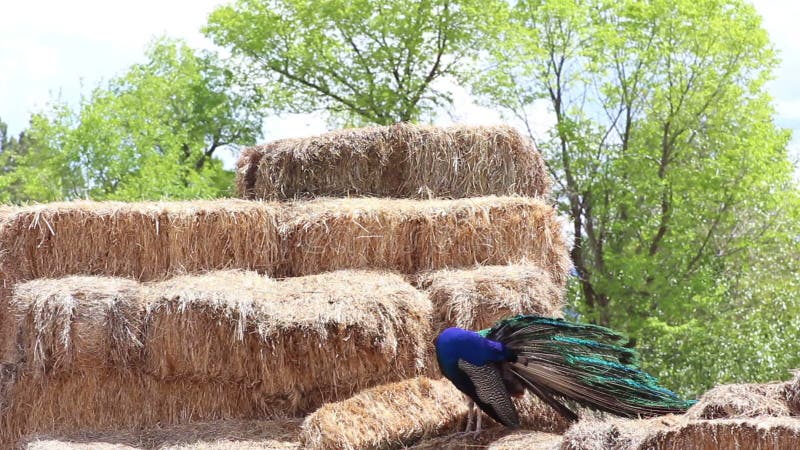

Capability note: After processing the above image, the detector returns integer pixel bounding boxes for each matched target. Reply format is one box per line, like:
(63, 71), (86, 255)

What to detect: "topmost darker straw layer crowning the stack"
(237, 124), (550, 200)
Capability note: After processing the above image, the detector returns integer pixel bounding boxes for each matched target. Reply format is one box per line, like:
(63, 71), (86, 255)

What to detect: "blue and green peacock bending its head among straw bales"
(436, 315), (694, 432)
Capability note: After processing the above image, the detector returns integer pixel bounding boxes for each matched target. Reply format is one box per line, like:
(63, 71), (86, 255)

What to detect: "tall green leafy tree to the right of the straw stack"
(476, 0), (800, 392)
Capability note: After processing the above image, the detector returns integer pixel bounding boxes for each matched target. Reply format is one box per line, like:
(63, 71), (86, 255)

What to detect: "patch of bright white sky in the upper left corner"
(0, 0), (223, 133)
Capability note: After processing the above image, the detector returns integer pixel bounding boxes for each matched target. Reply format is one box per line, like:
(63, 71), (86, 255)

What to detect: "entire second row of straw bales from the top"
(0, 197), (570, 286)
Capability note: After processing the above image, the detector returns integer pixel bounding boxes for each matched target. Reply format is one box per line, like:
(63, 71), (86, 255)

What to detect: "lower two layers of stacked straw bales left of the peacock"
(0, 271), (430, 442)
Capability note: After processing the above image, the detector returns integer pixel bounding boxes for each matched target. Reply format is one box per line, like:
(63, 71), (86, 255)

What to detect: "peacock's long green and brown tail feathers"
(480, 316), (693, 420)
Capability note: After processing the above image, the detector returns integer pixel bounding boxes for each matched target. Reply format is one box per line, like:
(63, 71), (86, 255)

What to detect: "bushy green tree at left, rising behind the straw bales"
(0, 40), (262, 201)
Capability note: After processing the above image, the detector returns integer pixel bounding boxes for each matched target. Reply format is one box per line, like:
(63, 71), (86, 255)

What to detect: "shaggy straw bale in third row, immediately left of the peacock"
(146, 271), (430, 411)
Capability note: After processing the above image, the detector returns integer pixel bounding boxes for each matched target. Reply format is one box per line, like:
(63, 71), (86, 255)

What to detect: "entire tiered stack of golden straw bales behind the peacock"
(0, 124), (571, 448)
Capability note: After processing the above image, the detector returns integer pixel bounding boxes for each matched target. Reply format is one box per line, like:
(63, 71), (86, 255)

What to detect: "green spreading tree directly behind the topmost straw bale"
(205, 0), (506, 124)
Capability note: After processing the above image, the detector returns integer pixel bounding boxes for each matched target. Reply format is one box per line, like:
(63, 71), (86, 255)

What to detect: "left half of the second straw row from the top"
(0, 200), (280, 286)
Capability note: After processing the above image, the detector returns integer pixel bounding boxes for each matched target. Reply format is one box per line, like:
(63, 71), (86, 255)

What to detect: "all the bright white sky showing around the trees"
(0, 0), (800, 169)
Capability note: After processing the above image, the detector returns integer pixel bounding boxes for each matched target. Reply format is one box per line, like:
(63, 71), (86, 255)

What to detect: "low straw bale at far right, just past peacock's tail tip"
(686, 383), (791, 419)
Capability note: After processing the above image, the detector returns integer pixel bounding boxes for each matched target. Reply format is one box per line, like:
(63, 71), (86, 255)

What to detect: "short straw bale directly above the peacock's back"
(417, 264), (564, 332)
